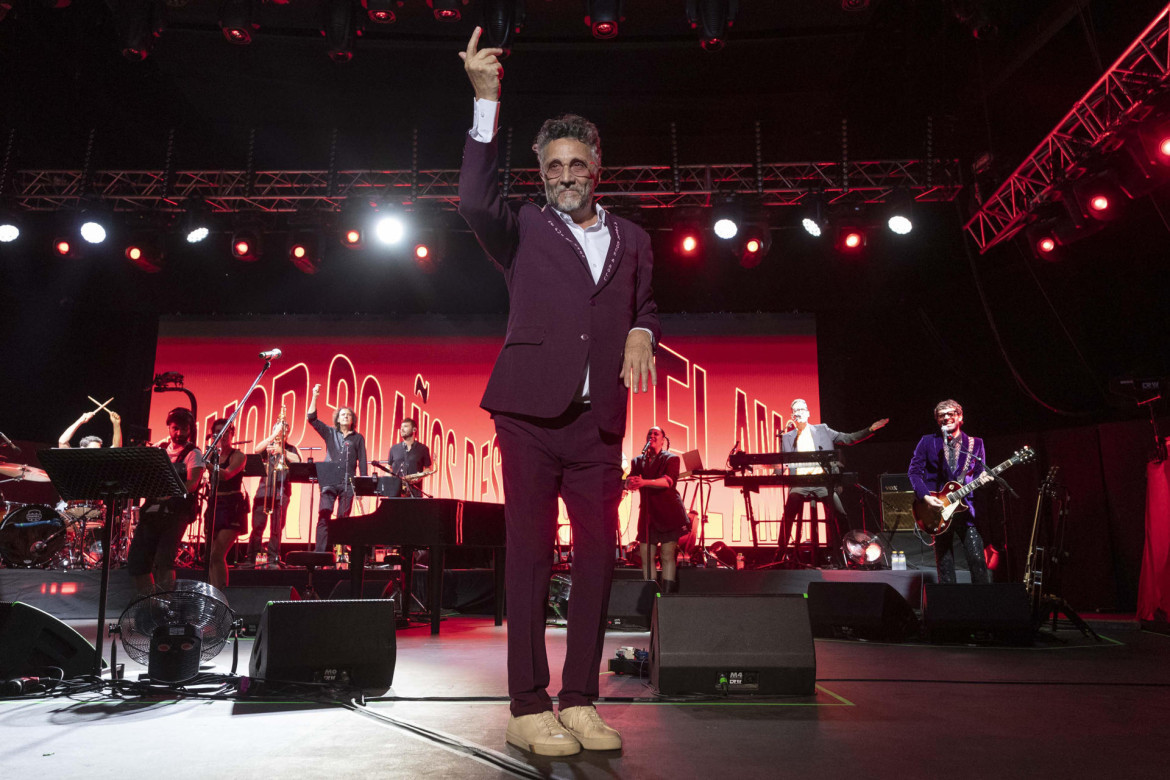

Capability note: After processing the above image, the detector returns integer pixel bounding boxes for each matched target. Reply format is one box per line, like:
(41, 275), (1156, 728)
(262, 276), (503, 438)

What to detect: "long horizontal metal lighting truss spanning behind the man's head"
(9, 160), (961, 214)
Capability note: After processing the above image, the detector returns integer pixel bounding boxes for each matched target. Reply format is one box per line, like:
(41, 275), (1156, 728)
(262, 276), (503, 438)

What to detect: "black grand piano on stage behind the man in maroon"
(329, 498), (505, 634)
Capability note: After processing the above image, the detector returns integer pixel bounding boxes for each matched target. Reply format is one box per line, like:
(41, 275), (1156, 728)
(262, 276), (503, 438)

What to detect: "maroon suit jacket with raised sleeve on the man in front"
(459, 134), (661, 435)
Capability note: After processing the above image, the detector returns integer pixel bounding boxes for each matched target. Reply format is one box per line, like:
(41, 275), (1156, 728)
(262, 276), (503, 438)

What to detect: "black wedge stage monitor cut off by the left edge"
(0, 601), (97, 681)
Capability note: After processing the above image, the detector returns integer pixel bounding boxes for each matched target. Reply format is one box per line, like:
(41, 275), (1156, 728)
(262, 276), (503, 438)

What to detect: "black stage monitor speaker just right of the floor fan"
(248, 599), (397, 692)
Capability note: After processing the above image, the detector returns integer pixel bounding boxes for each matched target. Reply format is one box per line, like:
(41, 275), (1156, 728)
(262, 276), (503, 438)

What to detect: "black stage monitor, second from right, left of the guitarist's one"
(808, 582), (918, 642)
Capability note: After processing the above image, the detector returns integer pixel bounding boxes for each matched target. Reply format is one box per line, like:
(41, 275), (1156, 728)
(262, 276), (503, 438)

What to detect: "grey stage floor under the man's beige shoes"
(0, 617), (1170, 780)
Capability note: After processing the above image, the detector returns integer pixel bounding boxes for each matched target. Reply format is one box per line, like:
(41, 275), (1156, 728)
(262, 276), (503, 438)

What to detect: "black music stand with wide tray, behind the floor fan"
(36, 447), (187, 677)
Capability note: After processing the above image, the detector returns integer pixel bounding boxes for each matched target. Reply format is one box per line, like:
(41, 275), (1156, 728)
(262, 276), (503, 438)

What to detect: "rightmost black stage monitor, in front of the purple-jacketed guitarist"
(922, 582), (1035, 644)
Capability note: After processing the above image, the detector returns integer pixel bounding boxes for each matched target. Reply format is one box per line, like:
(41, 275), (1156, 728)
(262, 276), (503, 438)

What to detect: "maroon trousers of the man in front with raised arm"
(494, 405), (621, 716)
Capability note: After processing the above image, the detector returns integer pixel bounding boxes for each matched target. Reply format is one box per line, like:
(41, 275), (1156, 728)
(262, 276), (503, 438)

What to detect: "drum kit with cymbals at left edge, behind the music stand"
(0, 462), (138, 570)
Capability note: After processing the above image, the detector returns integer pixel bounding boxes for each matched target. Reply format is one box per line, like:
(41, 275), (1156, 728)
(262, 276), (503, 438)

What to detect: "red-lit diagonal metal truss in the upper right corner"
(964, 6), (1170, 254)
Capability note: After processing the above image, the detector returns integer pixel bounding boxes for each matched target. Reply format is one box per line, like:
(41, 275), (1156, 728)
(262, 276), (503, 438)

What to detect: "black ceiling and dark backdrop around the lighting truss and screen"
(0, 0), (1170, 439)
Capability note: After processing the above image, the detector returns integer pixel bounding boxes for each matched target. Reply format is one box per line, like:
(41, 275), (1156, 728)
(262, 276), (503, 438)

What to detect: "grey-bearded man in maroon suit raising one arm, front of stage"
(459, 28), (660, 755)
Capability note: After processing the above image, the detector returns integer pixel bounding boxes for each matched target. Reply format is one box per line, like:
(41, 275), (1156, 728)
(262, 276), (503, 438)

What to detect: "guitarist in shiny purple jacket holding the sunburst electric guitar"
(909, 399), (992, 585)
